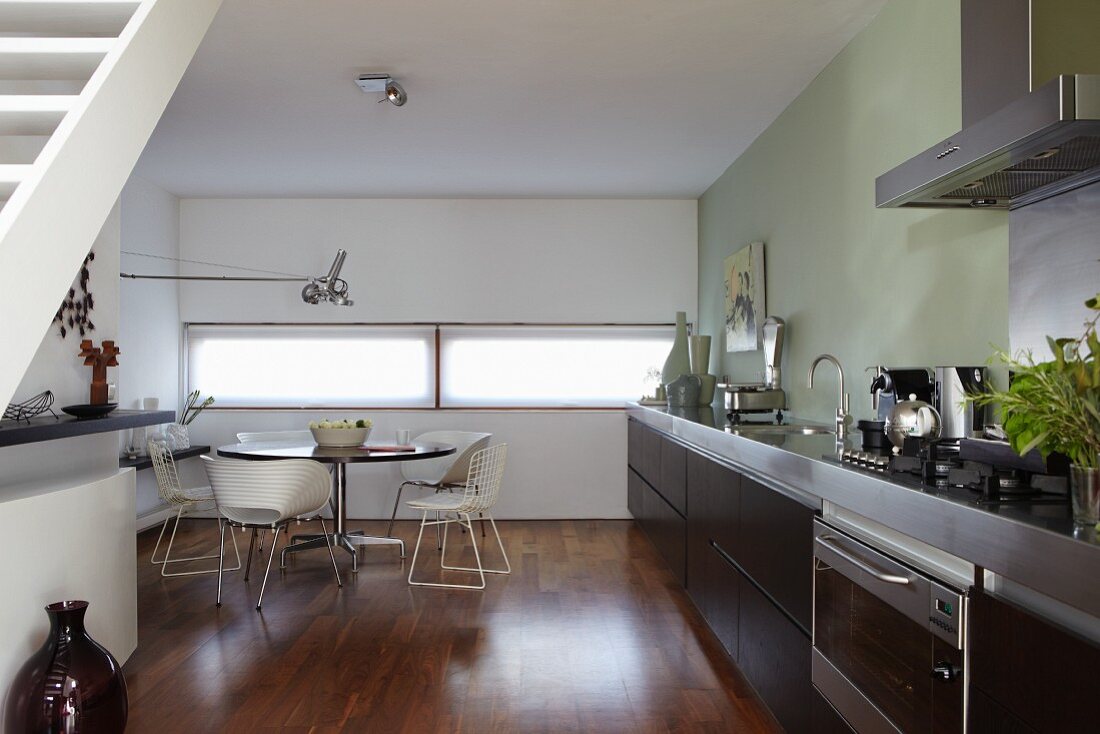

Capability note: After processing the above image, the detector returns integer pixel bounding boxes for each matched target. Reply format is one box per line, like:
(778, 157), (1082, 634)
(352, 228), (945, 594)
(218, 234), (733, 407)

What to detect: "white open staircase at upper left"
(0, 0), (221, 407)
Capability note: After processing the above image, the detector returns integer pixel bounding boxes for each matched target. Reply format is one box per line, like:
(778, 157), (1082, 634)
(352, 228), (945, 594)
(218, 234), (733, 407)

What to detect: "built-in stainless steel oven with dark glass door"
(812, 521), (967, 734)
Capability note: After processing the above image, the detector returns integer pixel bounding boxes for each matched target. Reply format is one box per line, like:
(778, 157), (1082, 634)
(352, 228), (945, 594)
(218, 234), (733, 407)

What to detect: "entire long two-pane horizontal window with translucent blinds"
(186, 325), (673, 408)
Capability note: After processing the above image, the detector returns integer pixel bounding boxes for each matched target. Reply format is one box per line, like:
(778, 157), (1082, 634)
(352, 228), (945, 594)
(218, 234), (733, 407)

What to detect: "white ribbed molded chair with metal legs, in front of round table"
(202, 457), (343, 612)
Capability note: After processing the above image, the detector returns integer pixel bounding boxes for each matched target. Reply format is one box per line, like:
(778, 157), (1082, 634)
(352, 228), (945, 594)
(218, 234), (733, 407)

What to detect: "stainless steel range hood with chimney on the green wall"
(875, 0), (1100, 209)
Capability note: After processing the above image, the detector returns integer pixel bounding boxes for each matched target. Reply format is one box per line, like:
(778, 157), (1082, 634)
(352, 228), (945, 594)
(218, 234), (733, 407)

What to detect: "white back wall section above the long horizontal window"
(179, 199), (696, 321)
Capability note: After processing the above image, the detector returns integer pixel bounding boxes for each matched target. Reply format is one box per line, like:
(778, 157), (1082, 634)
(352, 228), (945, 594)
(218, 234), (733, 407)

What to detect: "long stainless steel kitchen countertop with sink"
(627, 403), (1100, 617)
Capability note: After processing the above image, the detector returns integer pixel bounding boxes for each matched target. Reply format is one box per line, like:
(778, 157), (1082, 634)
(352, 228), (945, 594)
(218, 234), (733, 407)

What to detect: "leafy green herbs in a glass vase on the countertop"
(969, 294), (1100, 525)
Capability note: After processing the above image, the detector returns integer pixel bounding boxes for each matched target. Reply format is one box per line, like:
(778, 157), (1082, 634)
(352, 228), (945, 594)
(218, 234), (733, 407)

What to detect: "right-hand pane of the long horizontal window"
(439, 326), (673, 407)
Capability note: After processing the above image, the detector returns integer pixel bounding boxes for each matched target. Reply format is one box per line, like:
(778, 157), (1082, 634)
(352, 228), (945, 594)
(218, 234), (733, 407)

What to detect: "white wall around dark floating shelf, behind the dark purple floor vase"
(0, 206), (138, 719)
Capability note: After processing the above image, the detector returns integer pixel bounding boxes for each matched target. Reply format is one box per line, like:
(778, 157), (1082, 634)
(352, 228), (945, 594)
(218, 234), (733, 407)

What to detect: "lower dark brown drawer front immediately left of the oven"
(737, 580), (813, 732)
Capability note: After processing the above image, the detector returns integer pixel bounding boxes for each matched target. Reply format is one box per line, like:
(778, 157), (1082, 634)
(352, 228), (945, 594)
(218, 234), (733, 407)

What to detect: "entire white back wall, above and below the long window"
(173, 199), (696, 518)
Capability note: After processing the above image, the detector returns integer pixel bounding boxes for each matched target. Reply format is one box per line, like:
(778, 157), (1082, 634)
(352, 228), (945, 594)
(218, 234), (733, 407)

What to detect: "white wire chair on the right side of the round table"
(405, 443), (512, 589)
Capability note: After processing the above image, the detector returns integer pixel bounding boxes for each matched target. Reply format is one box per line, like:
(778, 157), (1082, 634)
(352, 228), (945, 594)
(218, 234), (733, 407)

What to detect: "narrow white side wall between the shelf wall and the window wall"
(119, 176), (179, 516)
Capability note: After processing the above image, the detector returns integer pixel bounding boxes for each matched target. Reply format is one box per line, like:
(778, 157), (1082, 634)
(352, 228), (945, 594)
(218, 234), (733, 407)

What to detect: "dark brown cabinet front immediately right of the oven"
(969, 590), (1100, 733)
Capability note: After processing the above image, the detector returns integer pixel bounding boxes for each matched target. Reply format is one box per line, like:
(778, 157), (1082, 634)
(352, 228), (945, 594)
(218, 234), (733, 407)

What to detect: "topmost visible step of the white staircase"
(0, 0), (141, 36)
